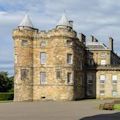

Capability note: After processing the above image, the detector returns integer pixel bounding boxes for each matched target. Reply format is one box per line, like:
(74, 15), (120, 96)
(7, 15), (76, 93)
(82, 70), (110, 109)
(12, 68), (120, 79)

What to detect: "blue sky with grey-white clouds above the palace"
(0, 0), (120, 75)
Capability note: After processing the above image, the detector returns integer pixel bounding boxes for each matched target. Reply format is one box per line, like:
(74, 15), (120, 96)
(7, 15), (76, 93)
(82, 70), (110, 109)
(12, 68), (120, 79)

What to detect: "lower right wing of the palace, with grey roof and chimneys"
(86, 36), (120, 98)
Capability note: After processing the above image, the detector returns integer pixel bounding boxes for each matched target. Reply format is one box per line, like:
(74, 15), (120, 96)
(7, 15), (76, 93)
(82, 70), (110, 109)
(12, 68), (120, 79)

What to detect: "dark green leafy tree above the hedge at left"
(0, 72), (13, 92)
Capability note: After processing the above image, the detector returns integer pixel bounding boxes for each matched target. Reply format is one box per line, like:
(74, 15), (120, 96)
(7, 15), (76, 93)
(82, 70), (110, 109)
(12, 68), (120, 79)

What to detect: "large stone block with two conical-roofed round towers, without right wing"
(13, 14), (85, 101)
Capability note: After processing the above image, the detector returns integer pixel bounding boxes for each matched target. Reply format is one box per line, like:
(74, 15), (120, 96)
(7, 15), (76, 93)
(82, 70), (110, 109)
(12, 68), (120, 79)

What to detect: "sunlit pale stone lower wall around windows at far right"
(96, 70), (120, 98)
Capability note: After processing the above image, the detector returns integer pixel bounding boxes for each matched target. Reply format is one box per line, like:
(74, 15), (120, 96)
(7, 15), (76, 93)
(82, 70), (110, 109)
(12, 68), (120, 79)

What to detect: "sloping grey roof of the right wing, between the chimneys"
(86, 42), (109, 50)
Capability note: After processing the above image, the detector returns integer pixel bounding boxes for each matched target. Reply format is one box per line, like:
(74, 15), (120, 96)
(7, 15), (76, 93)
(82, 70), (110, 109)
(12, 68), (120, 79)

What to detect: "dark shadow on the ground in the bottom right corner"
(79, 113), (120, 120)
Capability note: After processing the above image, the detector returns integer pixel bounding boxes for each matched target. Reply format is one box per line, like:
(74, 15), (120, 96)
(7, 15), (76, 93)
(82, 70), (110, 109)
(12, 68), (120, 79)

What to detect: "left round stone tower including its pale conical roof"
(13, 15), (37, 101)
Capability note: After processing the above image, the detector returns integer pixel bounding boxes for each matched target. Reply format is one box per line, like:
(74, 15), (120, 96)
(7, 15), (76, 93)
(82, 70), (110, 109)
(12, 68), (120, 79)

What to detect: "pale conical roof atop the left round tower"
(19, 14), (33, 28)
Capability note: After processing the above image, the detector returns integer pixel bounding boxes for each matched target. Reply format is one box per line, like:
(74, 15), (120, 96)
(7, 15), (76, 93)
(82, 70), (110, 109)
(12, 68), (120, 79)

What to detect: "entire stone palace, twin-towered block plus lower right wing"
(13, 14), (120, 101)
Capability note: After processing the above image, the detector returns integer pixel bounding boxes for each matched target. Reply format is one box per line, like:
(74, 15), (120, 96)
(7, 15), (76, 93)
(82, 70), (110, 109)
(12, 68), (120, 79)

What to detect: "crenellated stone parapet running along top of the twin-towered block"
(13, 27), (77, 39)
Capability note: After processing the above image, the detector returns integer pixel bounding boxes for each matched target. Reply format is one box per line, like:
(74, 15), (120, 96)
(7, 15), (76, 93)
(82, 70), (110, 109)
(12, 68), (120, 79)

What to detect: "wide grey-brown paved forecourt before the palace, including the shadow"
(0, 100), (120, 120)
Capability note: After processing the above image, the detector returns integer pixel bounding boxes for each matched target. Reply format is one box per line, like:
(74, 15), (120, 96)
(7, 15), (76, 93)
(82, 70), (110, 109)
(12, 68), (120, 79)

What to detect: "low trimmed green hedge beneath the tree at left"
(0, 92), (14, 101)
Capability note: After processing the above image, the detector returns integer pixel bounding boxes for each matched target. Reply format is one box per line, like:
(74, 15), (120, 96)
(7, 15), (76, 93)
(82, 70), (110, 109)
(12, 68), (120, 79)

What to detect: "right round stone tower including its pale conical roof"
(45, 14), (76, 100)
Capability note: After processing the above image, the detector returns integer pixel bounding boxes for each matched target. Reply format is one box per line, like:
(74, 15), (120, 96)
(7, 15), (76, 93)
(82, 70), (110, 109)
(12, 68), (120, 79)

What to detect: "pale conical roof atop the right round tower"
(57, 13), (71, 27)
